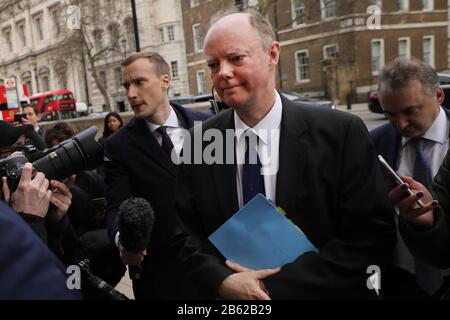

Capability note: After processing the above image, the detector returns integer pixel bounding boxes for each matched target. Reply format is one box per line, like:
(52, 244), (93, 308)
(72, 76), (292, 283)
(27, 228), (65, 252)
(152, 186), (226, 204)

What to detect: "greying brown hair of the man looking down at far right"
(378, 58), (439, 96)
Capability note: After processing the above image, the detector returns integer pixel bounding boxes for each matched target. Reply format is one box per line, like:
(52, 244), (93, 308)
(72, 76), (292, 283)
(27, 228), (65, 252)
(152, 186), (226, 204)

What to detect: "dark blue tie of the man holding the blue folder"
(242, 131), (266, 205)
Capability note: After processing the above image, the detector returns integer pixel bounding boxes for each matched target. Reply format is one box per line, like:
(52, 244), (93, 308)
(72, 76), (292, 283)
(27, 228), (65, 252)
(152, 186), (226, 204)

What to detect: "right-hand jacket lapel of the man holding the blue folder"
(276, 96), (308, 214)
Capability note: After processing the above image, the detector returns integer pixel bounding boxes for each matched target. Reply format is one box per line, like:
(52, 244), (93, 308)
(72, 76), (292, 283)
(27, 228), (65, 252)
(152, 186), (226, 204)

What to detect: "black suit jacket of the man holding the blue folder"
(174, 97), (395, 299)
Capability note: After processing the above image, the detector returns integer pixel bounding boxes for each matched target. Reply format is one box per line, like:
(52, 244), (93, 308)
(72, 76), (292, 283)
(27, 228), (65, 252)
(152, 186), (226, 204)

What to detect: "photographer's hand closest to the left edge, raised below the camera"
(12, 163), (52, 218)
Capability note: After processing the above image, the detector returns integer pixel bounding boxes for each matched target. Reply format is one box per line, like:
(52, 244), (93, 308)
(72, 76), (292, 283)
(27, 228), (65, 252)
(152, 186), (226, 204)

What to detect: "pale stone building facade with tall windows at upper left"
(0, 0), (188, 111)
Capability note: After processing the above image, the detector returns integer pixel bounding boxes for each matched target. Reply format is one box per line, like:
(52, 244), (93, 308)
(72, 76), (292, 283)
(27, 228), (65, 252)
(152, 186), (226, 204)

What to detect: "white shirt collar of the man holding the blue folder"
(234, 89), (282, 144)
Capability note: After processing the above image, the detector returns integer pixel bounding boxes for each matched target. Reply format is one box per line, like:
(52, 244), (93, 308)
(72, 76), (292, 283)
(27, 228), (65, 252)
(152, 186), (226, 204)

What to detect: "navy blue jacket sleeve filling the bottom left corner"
(0, 201), (80, 300)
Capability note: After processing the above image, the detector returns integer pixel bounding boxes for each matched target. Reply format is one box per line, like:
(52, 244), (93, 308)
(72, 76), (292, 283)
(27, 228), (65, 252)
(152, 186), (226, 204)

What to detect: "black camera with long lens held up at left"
(0, 126), (103, 192)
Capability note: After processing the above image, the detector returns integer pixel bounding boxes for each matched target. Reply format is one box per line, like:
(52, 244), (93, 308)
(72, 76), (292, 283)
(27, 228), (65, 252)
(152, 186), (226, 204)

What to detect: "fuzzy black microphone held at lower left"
(117, 198), (155, 280)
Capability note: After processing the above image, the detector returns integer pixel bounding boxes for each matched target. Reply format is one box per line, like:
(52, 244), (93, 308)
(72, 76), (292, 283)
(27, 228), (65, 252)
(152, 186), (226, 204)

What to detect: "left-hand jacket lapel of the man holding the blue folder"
(211, 110), (239, 219)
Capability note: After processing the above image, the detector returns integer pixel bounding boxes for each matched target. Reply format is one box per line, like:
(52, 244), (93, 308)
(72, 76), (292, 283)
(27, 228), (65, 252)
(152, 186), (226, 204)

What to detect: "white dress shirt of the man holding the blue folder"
(234, 91), (282, 208)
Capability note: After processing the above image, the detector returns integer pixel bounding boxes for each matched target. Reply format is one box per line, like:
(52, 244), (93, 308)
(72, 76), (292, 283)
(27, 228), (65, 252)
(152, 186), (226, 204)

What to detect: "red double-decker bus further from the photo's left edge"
(30, 90), (76, 120)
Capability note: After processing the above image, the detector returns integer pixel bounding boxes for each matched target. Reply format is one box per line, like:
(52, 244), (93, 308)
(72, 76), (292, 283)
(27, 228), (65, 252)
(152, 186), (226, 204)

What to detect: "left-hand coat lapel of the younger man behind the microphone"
(128, 118), (176, 176)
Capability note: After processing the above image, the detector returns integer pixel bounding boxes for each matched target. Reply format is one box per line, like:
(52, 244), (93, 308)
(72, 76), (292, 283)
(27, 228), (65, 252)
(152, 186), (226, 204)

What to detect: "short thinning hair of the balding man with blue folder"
(210, 7), (276, 47)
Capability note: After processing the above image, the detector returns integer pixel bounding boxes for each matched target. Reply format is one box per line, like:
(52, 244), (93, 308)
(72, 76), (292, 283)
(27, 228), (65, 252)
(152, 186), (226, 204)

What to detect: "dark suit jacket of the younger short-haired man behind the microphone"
(105, 105), (209, 299)
